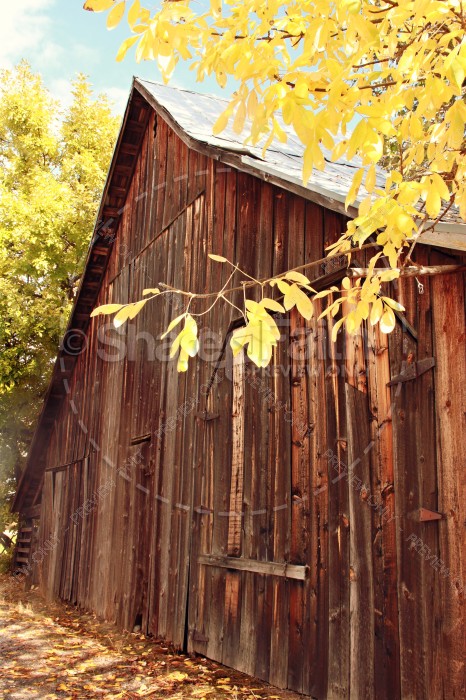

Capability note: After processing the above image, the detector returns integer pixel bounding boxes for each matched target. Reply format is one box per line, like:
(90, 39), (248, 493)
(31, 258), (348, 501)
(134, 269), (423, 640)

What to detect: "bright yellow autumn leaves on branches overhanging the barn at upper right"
(85, 0), (466, 369)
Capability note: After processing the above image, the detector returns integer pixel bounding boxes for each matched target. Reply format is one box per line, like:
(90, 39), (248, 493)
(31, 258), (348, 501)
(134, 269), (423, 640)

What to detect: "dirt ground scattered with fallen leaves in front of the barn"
(0, 575), (300, 700)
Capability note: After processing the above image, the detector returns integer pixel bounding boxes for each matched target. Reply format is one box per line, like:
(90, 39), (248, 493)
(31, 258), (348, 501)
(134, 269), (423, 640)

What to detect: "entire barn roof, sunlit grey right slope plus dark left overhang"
(13, 78), (466, 512)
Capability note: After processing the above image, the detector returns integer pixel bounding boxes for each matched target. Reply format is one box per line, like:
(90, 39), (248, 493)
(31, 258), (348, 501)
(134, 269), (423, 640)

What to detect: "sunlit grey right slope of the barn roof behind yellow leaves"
(135, 78), (466, 250)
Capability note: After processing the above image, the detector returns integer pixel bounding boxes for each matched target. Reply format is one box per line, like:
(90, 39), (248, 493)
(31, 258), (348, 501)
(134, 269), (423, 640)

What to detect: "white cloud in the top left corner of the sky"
(0, 0), (55, 68)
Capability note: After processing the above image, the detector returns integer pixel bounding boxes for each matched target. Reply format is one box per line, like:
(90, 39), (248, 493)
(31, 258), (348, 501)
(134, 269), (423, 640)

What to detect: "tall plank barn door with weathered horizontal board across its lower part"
(188, 318), (309, 690)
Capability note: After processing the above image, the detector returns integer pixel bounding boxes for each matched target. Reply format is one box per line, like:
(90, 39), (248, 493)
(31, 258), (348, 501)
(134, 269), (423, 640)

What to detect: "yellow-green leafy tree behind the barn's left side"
(0, 62), (119, 531)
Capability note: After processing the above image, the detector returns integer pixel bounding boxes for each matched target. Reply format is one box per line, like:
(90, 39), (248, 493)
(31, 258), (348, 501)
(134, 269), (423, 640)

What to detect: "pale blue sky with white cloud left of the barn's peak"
(0, 0), (229, 113)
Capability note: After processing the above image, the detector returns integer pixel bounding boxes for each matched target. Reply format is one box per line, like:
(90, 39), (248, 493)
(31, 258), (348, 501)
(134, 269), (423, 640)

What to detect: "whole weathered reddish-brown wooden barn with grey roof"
(14, 79), (466, 700)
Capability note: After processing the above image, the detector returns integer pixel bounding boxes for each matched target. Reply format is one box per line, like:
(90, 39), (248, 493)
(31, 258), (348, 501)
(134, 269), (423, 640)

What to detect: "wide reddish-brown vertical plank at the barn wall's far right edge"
(432, 266), (466, 698)
